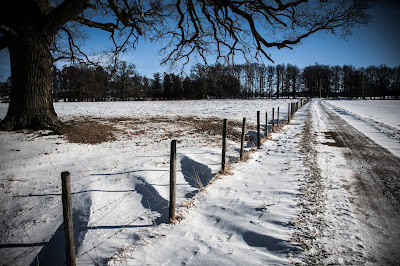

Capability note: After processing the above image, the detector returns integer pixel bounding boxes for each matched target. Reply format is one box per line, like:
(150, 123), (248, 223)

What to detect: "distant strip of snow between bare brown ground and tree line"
(0, 99), (293, 123)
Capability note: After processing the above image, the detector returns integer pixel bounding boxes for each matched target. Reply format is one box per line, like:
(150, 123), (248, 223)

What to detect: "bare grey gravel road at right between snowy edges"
(318, 102), (400, 265)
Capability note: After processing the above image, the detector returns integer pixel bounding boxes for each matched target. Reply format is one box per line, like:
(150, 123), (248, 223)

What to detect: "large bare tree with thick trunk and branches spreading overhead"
(0, 0), (372, 129)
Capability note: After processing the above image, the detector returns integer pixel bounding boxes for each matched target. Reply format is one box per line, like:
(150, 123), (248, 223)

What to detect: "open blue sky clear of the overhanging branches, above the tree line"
(0, 0), (400, 81)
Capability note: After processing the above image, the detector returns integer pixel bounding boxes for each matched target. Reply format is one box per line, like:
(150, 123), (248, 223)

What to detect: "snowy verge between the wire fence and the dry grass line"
(111, 104), (308, 265)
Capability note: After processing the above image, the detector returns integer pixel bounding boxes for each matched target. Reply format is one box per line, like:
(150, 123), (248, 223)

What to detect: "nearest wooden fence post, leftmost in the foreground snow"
(61, 172), (76, 266)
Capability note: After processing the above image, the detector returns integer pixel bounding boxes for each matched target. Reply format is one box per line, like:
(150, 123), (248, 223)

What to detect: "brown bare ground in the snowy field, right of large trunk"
(64, 116), (248, 145)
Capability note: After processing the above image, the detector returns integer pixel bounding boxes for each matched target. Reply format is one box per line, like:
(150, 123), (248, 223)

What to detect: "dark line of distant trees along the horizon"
(0, 61), (400, 101)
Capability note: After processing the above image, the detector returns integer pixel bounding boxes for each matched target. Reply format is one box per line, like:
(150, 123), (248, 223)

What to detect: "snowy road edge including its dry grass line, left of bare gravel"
(299, 101), (367, 265)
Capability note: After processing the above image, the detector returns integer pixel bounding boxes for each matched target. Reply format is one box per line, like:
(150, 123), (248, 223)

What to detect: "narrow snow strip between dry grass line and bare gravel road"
(310, 101), (366, 265)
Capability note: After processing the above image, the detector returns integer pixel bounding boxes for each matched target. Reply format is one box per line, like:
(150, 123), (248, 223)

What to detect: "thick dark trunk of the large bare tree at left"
(2, 33), (60, 130)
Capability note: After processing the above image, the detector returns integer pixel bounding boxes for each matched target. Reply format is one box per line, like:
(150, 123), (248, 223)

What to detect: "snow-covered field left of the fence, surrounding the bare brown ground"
(0, 100), (300, 265)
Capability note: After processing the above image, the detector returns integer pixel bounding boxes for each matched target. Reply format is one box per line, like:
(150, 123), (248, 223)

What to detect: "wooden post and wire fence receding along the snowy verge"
(18, 99), (308, 265)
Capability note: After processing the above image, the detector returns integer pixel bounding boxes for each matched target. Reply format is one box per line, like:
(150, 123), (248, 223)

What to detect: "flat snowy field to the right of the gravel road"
(324, 100), (400, 157)
